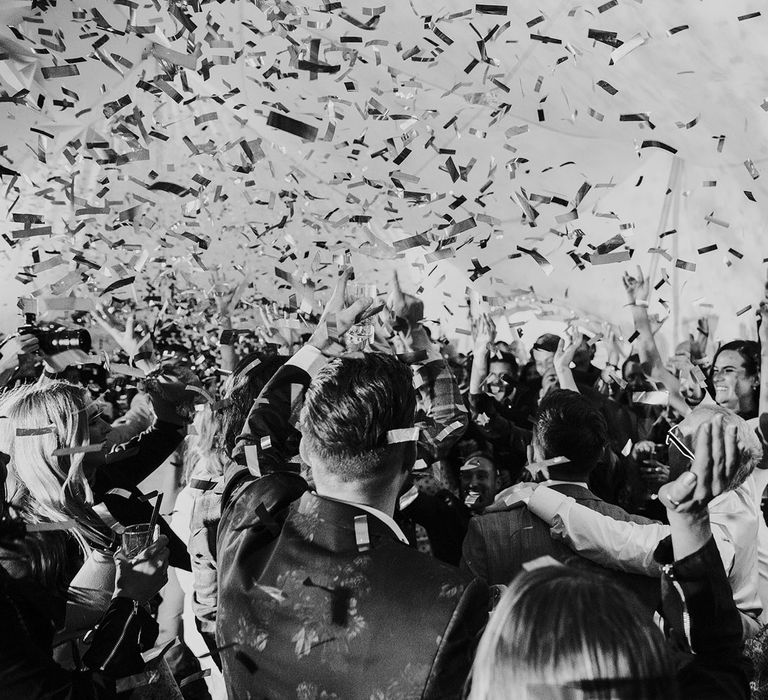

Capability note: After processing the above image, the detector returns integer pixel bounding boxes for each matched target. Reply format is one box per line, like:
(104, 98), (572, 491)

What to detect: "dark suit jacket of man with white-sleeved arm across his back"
(462, 484), (660, 609)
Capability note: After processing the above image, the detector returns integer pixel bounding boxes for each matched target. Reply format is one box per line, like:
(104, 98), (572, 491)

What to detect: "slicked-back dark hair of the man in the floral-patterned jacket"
(301, 353), (416, 483)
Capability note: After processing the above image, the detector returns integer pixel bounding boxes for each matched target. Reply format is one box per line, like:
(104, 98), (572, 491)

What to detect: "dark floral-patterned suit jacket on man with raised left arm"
(216, 352), (488, 700)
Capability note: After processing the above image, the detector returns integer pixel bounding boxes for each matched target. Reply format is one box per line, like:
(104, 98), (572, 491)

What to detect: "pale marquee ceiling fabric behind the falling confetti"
(0, 0), (768, 344)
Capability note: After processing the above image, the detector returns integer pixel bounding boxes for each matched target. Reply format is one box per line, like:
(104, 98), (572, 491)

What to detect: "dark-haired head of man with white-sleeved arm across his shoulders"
(533, 389), (608, 476)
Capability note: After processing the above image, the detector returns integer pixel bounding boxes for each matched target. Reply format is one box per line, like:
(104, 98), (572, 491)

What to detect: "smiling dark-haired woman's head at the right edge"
(710, 340), (760, 420)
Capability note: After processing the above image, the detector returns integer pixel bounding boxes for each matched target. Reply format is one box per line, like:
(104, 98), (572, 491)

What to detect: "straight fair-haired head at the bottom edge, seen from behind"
(469, 566), (677, 700)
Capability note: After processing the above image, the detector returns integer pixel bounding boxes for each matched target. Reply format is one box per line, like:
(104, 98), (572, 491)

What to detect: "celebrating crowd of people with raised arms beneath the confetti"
(0, 268), (768, 700)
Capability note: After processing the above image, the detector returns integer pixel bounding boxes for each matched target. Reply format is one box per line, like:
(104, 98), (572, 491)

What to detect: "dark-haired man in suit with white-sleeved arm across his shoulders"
(462, 389), (658, 606)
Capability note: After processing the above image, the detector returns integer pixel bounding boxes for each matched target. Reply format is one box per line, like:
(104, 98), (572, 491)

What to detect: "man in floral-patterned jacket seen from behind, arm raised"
(217, 274), (488, 700)
